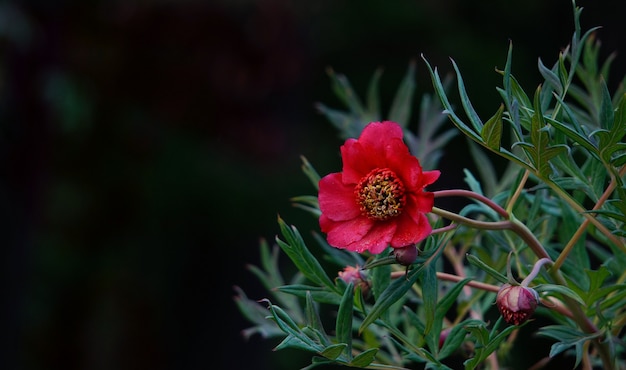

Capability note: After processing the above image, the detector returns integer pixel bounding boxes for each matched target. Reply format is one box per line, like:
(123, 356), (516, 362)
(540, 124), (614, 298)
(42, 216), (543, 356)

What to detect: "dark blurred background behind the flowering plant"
(0, 0), (626, 370)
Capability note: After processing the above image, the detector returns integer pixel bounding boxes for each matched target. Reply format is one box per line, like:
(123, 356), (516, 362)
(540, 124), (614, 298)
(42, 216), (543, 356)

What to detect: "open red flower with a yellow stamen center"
(318, 121), (439, 254)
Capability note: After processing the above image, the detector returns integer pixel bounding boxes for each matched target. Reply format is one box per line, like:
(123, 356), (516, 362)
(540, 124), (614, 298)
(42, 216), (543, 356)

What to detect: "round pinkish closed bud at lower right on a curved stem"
(496, 284), (539, 325)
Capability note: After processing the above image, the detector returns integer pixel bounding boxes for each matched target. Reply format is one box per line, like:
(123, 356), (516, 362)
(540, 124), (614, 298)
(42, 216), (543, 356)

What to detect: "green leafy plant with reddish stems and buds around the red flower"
(235, 2), (626, 369)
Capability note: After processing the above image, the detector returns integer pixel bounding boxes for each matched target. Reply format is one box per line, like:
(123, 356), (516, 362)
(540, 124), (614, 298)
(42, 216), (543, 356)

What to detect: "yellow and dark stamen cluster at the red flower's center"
(354, 168), (406, 221)
